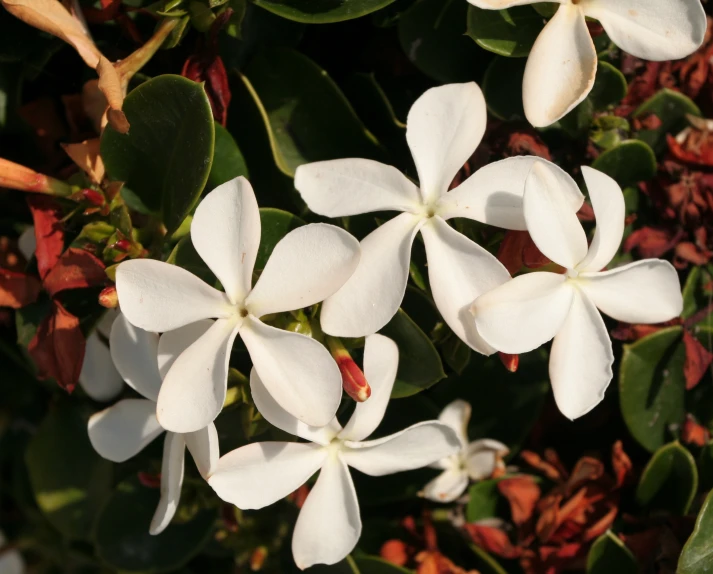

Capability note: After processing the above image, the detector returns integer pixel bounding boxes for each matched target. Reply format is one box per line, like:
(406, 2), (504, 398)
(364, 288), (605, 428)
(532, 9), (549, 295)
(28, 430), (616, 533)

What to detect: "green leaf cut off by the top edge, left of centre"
(254, 0), (394, 24)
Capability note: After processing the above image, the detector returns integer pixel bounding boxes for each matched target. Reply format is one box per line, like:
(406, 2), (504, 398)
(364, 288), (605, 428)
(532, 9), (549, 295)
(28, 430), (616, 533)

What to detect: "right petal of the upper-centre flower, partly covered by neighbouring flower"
(437, 156), (584, 231)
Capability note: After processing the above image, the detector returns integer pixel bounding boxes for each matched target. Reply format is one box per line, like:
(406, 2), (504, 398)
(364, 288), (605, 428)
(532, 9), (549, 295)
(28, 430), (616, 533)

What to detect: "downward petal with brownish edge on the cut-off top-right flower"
(522, 4), (597, 128)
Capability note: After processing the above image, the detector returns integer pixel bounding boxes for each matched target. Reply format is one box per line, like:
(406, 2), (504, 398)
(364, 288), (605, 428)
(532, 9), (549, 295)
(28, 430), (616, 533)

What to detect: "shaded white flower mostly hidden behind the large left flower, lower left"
(88, 315), (220, 534)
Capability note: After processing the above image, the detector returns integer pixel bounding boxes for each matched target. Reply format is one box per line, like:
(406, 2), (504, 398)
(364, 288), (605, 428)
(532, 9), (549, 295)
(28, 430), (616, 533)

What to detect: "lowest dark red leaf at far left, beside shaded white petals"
(28, 300), (86, 393)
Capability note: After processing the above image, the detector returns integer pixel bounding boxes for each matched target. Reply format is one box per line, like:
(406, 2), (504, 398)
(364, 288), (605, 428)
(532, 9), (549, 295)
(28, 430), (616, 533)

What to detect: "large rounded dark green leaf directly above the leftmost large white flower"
(101, 75), (215, 235)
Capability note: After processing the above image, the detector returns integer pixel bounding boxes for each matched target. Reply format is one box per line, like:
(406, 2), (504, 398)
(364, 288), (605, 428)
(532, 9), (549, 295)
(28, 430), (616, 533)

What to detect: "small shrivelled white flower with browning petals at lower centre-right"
(421, 399), (509, 502)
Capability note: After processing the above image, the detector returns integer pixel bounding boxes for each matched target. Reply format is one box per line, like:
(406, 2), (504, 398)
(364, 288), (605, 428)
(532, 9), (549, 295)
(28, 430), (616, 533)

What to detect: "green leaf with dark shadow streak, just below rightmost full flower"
(619, 327), (686, 452)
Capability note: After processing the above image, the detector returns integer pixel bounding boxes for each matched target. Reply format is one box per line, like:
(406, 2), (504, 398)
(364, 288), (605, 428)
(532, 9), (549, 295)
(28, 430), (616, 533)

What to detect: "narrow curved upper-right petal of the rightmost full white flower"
(577, 166), (626, 271)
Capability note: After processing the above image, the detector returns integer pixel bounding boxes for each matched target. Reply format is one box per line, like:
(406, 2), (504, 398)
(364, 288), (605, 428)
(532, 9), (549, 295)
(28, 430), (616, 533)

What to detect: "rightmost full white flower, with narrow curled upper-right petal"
(473, 163), (683, 419)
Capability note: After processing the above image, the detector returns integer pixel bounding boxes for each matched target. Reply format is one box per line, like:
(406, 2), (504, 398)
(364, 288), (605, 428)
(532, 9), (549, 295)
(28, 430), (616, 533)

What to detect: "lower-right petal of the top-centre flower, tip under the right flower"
(421, 216), (510, 355)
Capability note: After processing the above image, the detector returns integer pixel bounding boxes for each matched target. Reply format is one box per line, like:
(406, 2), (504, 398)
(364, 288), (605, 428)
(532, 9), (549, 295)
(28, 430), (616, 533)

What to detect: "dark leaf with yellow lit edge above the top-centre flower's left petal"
(245, 48), (383, 177)
